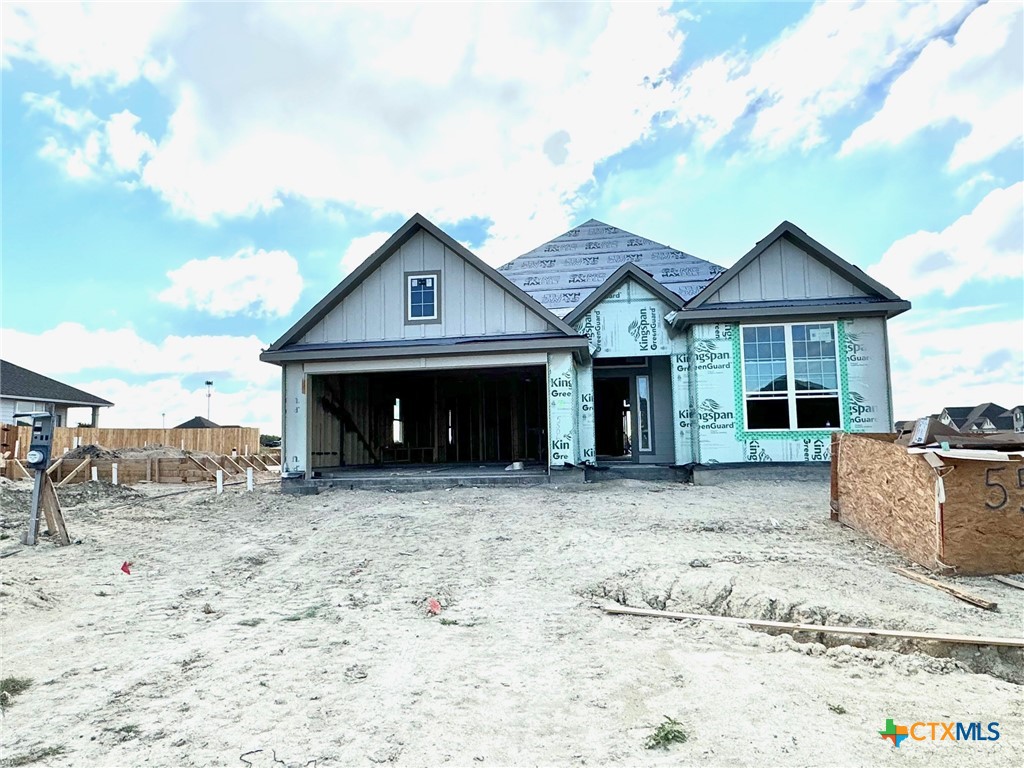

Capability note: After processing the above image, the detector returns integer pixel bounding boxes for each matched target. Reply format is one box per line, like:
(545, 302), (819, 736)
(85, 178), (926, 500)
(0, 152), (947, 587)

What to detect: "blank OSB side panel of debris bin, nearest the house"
(833, 434), (938, 568)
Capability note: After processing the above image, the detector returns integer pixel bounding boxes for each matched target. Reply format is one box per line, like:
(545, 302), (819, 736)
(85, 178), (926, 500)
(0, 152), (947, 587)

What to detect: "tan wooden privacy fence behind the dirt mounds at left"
(0, 424), (260, 459)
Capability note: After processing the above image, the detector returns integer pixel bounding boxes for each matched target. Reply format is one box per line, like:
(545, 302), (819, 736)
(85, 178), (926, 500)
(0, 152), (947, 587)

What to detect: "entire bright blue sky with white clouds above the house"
(0, 1), (1024, 432)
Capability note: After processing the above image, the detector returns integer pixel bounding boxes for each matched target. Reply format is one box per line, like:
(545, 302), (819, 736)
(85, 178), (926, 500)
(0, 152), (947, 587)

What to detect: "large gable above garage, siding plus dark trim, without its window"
(269, 214), (573, 351)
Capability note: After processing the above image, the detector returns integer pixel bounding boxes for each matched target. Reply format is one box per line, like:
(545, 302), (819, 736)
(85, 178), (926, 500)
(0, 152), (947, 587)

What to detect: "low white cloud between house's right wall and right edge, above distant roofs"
(889, 312), (1024, 420)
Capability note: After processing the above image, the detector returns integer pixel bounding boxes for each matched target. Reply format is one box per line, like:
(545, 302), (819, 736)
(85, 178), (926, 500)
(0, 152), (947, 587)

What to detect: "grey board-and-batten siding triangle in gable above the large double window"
(706, 238), (866, 304)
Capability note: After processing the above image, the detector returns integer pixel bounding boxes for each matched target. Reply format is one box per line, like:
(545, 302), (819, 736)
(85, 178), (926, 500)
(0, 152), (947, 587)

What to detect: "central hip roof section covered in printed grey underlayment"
(498, 219), (725, 316)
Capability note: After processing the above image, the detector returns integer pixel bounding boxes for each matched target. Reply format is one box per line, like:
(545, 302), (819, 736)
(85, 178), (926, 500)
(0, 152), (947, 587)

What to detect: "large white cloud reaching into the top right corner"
(841, 2), (1024, 170)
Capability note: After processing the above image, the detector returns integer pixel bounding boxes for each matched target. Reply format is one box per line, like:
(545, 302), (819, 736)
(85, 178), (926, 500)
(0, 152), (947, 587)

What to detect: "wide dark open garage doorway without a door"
(309, 366), (547, 469)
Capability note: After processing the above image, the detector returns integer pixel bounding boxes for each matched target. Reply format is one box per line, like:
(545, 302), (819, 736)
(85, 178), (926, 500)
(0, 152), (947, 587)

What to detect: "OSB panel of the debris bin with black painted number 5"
(940, 459), (1024, 575)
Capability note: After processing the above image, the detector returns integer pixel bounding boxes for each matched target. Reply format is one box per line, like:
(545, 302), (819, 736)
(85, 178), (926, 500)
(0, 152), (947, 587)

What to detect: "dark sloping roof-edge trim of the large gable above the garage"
(266, 213), (577, 352)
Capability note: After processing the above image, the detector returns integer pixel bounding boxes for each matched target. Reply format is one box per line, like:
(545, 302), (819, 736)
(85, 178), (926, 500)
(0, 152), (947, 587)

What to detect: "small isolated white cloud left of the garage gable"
(158, 248), (302, 317)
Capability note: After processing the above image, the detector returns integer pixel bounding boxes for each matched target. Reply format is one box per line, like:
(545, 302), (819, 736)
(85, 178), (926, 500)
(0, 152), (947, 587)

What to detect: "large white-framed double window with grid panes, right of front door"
(742, 323), (841, 430)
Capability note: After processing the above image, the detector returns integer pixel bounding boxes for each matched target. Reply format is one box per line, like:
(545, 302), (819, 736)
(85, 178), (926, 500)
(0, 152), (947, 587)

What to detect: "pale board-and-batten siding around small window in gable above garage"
(299, 231), (554, 344)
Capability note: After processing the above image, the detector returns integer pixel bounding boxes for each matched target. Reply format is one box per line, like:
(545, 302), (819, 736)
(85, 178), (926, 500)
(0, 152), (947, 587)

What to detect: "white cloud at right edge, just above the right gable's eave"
(868, 182), (1024, 297)
